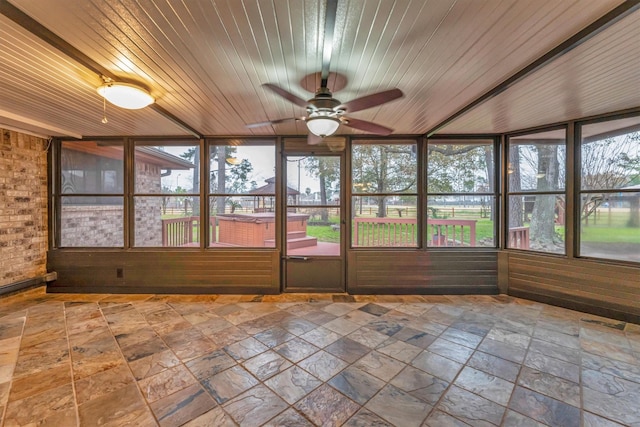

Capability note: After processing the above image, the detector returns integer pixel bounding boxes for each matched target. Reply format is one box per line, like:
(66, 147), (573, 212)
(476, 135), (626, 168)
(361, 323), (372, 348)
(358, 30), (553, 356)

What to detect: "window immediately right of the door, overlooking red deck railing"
(351, 141), (418, 247)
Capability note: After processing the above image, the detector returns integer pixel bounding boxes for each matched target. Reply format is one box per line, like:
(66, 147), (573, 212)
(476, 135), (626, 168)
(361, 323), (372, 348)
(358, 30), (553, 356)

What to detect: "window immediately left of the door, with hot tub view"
(208, 140), (276, 248)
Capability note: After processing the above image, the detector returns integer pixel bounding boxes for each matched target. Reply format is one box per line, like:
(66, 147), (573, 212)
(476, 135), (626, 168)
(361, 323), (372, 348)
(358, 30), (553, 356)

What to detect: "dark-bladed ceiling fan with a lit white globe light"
(247, 83), (403, 145)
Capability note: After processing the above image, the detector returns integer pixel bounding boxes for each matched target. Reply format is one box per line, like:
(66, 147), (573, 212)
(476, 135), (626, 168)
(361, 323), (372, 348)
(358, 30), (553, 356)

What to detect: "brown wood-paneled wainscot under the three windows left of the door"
(47, 249), (280, 294)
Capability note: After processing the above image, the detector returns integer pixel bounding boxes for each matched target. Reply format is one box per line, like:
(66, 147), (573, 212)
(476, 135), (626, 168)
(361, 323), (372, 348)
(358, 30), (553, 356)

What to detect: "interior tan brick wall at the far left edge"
(0, 129), (48, 286)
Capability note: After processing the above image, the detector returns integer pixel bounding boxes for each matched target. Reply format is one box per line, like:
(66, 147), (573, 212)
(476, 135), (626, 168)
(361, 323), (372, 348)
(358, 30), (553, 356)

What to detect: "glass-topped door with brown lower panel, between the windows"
(283, 154), (345, 292)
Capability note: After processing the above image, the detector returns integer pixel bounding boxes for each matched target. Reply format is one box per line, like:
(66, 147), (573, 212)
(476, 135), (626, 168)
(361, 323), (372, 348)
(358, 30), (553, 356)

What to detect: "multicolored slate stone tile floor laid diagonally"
(0, 290), (640, 427)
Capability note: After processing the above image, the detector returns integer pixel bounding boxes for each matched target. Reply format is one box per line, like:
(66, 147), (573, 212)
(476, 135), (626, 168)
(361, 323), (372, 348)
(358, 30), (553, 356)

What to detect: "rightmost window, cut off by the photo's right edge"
(579, 117), (640, 262)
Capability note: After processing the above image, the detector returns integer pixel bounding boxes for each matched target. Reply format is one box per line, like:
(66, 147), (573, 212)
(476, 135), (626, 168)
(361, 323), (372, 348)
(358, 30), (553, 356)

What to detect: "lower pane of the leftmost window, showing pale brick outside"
(60, 196), (124, 248)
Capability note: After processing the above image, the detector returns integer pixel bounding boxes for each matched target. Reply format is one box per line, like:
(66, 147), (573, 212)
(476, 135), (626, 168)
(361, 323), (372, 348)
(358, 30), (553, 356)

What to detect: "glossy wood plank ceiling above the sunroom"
(0, 0), (640, 137)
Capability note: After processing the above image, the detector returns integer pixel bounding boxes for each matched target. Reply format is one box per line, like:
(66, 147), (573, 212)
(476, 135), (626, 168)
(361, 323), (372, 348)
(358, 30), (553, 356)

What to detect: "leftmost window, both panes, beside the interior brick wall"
(58, 141), (124, 247)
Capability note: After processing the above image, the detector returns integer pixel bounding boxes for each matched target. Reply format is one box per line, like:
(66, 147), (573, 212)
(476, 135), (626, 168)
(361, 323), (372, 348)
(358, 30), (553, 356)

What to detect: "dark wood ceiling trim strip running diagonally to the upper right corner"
(425, 0), (640, 137)
